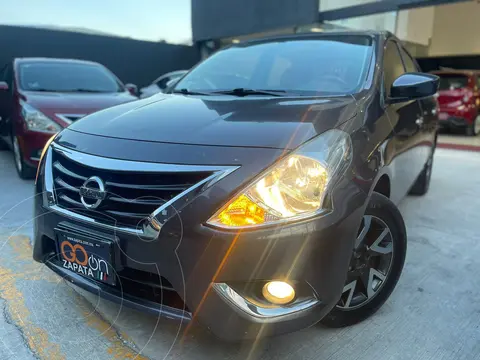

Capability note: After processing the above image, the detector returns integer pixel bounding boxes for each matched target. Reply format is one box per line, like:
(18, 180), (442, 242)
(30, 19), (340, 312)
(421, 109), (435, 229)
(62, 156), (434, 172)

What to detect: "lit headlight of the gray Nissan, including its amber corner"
(207, 129), (352, 228)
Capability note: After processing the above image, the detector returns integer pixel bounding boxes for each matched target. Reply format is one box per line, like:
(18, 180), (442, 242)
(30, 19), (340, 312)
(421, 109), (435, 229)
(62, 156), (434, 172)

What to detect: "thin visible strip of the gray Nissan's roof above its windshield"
(233, 30), (388, 46)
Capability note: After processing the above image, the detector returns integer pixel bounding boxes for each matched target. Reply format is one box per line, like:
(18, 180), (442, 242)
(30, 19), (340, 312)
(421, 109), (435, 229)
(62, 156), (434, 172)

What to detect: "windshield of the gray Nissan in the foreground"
(174, 35), (372, 95)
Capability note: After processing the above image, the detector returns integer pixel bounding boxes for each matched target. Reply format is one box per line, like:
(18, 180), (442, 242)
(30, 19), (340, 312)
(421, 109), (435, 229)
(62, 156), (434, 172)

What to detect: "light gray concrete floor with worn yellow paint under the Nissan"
(0, 149), (480, 360)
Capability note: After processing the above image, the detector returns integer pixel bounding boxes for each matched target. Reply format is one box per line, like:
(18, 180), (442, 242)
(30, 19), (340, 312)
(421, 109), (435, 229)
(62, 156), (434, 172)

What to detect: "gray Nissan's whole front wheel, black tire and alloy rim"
(322, 193), (407, 327)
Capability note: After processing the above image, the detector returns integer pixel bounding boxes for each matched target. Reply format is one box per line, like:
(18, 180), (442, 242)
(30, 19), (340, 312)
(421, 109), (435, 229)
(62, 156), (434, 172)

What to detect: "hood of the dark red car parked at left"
(21, 91), (137, 126)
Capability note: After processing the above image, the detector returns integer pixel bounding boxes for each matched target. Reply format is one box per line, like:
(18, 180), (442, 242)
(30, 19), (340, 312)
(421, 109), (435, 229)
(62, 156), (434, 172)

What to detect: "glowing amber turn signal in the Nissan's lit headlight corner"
(217, 195), (265, 227)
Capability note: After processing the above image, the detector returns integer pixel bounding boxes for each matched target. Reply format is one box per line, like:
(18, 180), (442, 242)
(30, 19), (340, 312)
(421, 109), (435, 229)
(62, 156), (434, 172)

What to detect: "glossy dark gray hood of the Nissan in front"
(69, 94), (356, 149)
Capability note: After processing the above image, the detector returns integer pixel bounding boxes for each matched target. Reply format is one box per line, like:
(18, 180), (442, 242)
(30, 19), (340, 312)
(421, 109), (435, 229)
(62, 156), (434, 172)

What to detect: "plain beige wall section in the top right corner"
(429, 1), (480, 56)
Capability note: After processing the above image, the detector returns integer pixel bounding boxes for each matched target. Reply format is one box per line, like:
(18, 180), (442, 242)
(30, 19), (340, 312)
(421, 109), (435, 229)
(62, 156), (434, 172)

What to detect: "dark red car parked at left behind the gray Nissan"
(0, 58), (137, 179)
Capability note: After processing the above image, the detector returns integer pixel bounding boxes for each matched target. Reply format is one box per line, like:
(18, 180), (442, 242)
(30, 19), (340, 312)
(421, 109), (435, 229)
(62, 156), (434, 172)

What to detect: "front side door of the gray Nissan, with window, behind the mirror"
(383, 40), (424, 197)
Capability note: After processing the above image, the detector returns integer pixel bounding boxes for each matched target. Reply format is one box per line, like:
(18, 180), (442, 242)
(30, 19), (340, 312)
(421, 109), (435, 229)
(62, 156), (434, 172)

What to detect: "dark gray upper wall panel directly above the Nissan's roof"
(192, 0), (319, 41)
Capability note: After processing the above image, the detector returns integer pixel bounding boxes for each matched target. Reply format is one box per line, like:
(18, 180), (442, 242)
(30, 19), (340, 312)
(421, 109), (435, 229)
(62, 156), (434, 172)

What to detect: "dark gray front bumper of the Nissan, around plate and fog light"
(33, 200), (361, 340)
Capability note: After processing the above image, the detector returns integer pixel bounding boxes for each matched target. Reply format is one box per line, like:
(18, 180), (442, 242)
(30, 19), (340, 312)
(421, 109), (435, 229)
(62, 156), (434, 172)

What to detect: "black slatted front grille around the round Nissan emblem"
(52, 151), (212, 229)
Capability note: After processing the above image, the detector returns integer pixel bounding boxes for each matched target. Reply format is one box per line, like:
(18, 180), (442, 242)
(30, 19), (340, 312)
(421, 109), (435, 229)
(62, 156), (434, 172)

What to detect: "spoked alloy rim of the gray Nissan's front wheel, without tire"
(337, 215), (393, 310)
